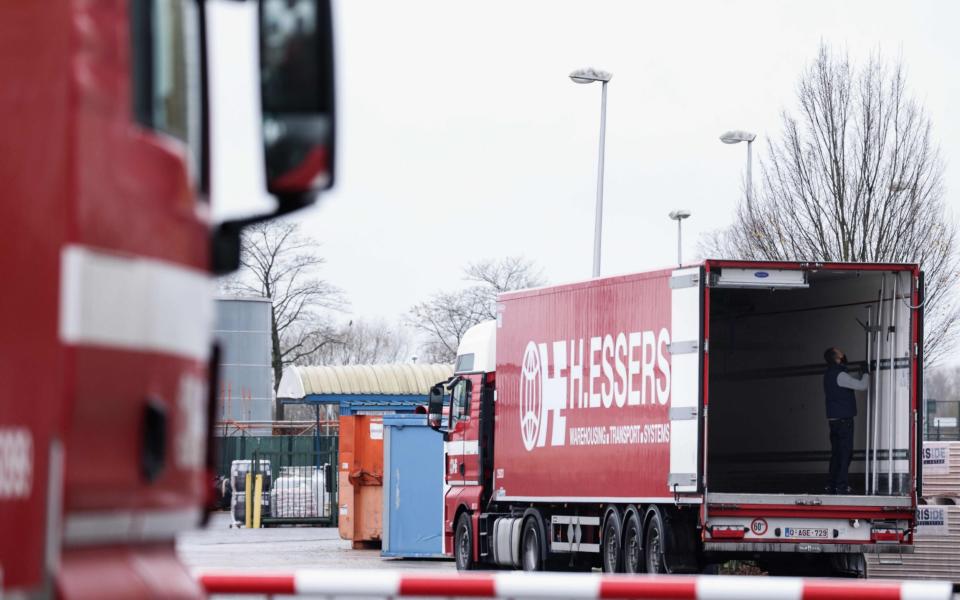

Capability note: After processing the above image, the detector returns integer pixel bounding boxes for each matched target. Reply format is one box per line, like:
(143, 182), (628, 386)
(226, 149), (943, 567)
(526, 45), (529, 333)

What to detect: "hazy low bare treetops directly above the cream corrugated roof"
(297, 320), (410, 365)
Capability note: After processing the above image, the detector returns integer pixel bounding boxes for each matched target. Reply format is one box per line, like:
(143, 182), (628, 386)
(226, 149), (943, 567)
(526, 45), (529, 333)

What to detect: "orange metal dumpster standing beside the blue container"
(338, 415), (383, 548)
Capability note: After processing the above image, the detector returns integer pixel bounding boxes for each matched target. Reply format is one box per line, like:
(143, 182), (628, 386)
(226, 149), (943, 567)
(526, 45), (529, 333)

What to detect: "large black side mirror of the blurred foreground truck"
(260, 0), (335, 206)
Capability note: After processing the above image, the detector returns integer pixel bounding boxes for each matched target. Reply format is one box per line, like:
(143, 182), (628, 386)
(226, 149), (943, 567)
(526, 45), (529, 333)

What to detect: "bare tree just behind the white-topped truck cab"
(408, 256), (545, 363)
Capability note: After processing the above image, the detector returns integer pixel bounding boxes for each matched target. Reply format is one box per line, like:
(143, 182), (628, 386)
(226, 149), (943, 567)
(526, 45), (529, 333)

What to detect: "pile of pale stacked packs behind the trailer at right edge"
(866, 442), (960, 583)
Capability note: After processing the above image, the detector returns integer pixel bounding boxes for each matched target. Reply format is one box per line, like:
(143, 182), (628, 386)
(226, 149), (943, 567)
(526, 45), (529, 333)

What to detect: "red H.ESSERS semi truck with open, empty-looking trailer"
(430, 260), (923, 574)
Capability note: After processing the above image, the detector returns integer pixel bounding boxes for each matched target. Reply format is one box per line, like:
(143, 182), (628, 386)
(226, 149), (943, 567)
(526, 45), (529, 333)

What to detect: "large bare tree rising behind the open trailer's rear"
(700, 45), (958, 364)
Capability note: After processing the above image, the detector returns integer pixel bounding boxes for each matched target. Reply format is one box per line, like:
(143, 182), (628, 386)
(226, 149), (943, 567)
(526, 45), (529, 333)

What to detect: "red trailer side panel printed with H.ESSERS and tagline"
(494, 271), (671, 502)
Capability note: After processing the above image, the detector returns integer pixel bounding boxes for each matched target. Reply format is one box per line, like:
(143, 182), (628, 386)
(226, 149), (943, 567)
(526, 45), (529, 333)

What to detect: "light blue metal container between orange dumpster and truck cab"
(380, 414), (444, 558)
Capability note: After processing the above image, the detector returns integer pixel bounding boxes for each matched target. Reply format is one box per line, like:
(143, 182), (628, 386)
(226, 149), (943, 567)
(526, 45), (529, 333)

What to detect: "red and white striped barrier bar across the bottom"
(198, 570), (953, 600)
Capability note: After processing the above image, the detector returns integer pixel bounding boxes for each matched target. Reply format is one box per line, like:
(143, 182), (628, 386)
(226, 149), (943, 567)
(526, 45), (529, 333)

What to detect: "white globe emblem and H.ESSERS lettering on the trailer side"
(519, 329), (670, 451)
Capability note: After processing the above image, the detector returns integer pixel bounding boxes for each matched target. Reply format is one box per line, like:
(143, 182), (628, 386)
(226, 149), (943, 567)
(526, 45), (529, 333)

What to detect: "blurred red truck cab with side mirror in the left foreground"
(0, 0), (333, 599)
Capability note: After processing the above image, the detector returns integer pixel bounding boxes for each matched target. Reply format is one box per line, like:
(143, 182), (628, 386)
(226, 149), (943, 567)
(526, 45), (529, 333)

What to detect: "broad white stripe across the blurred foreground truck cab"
(59, 244), (214, 360)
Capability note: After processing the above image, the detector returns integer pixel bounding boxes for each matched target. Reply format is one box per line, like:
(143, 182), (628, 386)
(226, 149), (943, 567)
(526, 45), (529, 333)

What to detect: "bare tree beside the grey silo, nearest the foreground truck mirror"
(222, 221), (345, 412)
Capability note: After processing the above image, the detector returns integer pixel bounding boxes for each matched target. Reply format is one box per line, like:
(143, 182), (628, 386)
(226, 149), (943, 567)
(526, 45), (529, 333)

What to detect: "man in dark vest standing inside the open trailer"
(823, 348), (870, 494)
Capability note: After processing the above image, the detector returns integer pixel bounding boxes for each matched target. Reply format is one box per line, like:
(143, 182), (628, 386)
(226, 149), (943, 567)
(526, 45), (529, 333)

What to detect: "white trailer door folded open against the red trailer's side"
(667, 266), (706, 494)
